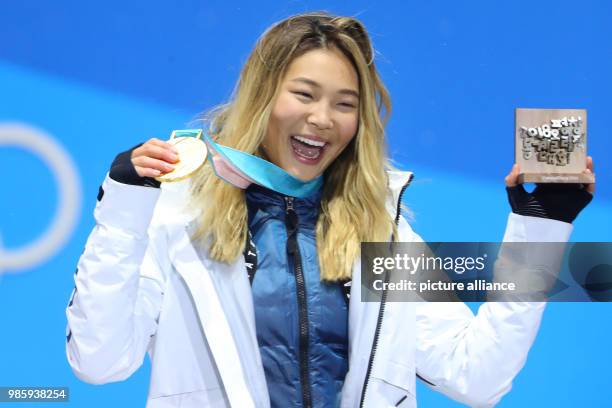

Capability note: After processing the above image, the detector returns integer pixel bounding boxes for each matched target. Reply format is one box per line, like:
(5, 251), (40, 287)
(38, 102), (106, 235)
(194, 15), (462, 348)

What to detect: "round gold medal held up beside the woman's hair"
(155, 129), (208, 183)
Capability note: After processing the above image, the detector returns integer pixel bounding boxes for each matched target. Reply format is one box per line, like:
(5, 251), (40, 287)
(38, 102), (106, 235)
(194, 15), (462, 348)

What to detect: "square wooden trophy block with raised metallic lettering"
(515, 109), (595, 183)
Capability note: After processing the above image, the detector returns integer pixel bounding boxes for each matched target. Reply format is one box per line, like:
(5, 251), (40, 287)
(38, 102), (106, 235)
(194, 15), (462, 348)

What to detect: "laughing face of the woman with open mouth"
(262, 48), (359, 181)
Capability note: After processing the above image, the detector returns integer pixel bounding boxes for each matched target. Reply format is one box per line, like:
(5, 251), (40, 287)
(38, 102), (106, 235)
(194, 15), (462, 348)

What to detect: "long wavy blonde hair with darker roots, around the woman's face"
(190, 12), (395, 281)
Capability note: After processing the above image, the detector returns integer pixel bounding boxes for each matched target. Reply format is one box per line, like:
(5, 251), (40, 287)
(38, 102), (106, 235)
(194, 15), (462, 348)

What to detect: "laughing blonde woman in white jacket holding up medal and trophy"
(67, 13), (593, 407)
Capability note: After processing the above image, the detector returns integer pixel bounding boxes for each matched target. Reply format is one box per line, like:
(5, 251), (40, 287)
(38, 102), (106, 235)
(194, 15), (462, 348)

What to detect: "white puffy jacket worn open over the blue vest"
(66, 172), (572, 408)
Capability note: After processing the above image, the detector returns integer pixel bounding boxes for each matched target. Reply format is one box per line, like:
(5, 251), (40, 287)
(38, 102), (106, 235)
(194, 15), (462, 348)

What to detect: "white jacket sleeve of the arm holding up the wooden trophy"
(416, 214), (572, 407)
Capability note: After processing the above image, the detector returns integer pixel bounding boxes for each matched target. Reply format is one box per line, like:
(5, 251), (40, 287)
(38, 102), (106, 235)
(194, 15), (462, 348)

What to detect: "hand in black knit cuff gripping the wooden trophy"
(505, 156), (595, 223)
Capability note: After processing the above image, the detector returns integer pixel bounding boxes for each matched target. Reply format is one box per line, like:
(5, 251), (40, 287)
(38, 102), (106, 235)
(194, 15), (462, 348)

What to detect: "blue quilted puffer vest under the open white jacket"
(246, 185), (348, 408)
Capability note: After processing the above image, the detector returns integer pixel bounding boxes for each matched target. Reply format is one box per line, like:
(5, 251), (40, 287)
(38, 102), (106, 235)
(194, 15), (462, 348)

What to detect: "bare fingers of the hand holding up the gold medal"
(131, 138), (179, 177)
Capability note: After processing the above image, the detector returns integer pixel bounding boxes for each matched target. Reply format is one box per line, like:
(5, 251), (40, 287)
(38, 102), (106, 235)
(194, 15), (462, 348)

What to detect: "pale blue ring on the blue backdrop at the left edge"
(0, 122), (82, 276)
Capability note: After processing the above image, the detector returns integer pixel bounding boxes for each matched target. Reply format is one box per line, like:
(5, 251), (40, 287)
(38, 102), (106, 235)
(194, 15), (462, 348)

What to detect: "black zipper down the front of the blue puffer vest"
(285, 197), (312, 408)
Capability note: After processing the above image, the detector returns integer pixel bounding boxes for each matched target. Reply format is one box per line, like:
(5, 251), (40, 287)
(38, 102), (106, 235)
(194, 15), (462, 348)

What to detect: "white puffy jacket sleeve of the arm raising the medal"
(66, 176), (163, 384)
